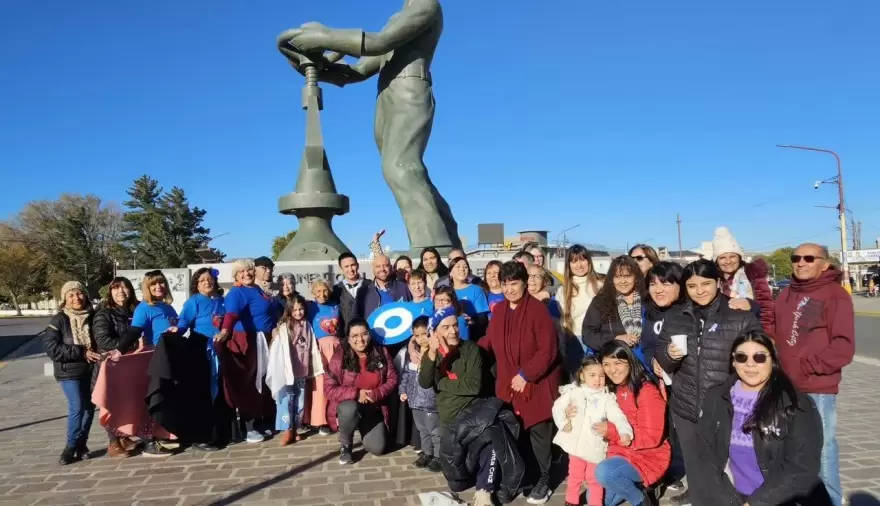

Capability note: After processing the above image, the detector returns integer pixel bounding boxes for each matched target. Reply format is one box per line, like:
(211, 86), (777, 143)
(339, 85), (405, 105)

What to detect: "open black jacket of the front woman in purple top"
(691, 375), (831, 506)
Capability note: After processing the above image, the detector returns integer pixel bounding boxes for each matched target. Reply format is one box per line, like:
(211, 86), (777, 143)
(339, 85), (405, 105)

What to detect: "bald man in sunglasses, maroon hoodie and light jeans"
(775, 243), (855, 506)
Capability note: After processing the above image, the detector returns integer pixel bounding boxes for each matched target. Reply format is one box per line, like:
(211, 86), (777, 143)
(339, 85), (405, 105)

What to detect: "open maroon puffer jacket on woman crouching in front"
(324, 344), (397, 431)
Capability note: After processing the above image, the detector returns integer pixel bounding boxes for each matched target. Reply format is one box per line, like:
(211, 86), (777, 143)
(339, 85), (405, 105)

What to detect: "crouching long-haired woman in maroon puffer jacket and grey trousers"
(324, 318), (397, 464)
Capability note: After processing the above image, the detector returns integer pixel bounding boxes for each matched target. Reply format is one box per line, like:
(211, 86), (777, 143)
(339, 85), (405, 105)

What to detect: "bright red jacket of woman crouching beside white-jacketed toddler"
(605, 382), (672, 485)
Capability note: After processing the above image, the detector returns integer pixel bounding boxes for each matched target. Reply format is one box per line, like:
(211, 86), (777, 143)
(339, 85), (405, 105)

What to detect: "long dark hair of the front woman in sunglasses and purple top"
(730, 332), (798, 440)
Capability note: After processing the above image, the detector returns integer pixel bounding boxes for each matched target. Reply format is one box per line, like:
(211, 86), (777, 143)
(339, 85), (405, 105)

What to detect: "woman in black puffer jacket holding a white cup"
(654, 259), (761, 504)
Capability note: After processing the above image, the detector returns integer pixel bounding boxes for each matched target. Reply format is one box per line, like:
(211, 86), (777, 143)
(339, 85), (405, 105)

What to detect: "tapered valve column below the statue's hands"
(278, 65), (349, 262)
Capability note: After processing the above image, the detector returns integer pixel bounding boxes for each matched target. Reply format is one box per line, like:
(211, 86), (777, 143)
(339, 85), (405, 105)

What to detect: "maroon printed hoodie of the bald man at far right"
(775, 268), (856, 394)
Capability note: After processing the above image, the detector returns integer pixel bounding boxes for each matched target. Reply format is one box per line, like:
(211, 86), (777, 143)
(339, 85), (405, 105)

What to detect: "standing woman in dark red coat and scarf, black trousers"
(479, 262), (561, 504)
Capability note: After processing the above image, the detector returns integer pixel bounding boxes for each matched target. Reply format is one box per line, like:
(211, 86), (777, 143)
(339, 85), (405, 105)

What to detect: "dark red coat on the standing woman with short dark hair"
(479, 294), (561, 429)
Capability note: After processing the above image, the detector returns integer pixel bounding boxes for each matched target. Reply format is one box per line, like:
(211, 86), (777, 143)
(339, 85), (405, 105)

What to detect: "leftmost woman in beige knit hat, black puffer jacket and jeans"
(43, 281), (101, 465)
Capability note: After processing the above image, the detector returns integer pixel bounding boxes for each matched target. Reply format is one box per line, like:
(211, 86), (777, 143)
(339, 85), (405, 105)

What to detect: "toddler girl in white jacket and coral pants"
(553, 356), (633, 506)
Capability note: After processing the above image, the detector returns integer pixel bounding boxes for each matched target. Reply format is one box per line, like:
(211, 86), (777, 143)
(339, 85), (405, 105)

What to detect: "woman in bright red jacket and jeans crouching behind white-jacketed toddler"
(567, 341), (672, 506)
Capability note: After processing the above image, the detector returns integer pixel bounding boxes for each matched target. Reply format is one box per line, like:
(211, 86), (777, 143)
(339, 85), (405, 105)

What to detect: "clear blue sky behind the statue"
(0, 0), (880, 256)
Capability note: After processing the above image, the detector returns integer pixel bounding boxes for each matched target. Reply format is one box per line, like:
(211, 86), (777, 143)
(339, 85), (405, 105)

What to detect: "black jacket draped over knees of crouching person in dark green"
(440, 398), (525, 504)
